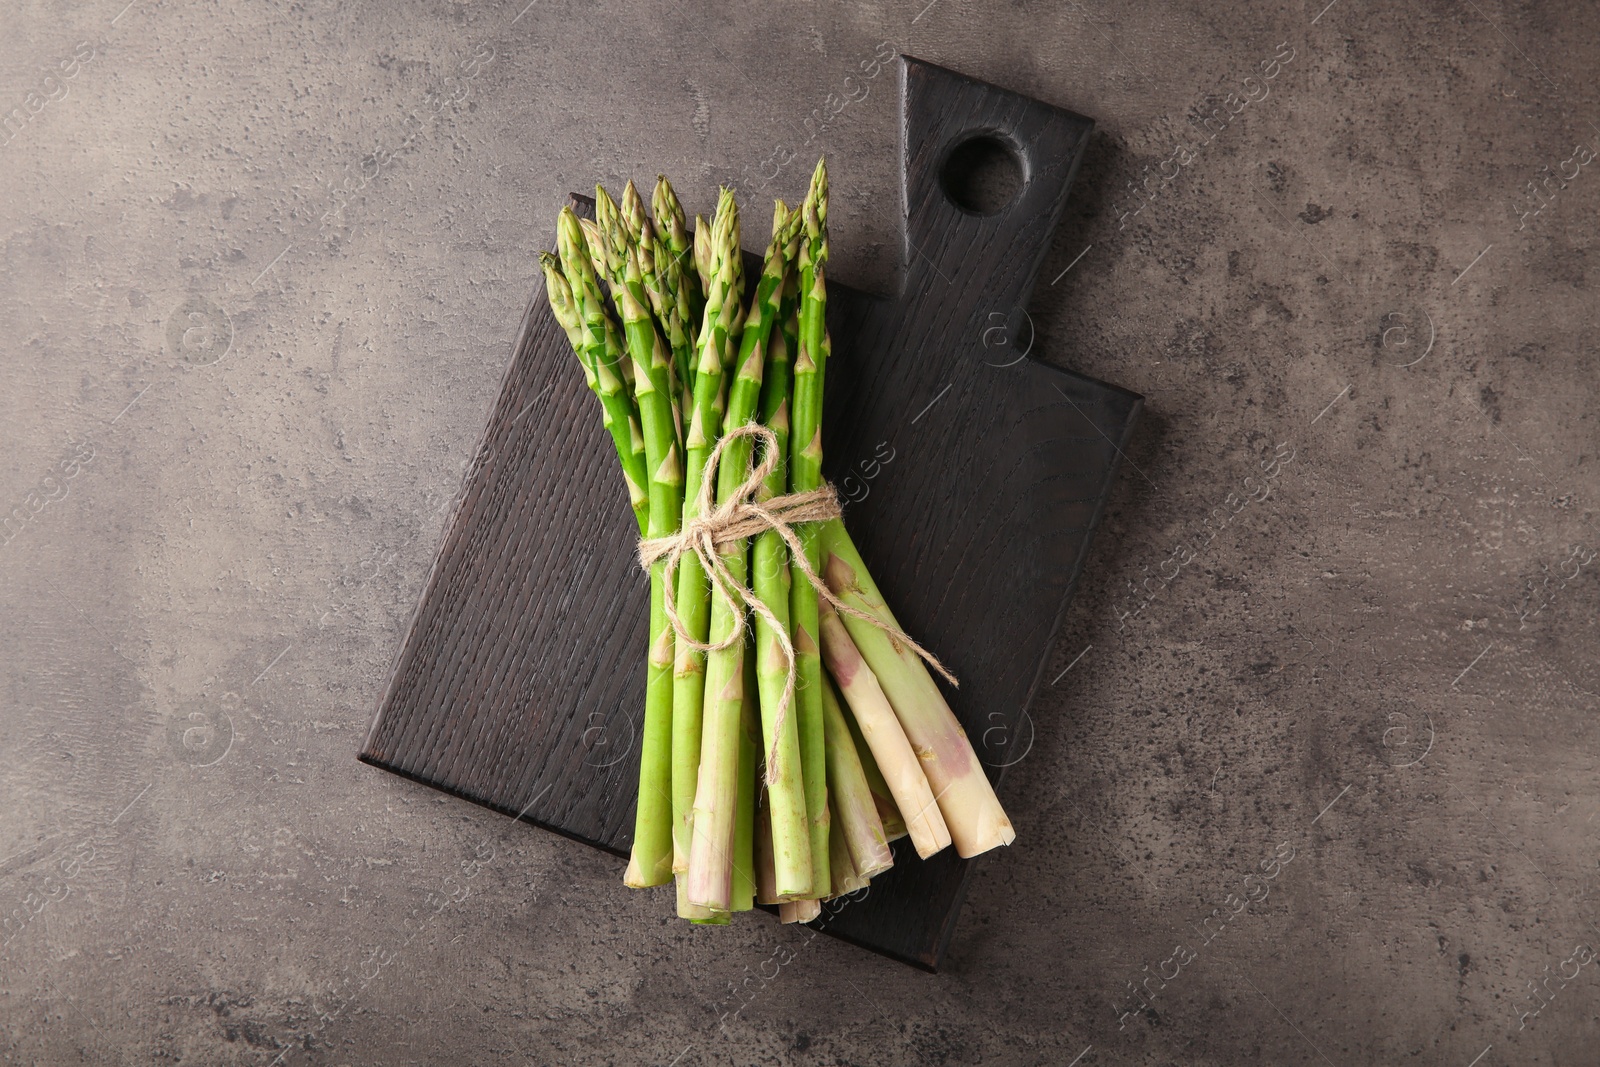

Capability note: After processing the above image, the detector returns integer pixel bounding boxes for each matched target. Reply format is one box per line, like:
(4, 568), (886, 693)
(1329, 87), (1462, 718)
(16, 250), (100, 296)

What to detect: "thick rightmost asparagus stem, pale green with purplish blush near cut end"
(821, 520), (1016, 857)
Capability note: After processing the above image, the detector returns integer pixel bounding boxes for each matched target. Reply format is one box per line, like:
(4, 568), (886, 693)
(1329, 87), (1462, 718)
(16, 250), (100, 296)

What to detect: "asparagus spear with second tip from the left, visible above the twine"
(546, 208), (650, 533)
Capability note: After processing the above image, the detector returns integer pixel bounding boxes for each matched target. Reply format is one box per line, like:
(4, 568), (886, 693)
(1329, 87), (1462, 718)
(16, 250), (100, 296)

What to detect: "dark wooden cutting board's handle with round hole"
(901, 56), (1094, 306)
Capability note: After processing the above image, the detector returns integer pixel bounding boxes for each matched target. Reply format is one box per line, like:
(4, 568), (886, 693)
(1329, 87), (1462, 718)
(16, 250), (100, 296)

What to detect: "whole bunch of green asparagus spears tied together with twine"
(541, 160), (1014, 923)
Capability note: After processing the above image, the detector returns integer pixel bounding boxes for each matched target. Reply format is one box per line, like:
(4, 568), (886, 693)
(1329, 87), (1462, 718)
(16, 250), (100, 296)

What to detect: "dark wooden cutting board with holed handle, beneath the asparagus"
(360, 56), (1141, 969)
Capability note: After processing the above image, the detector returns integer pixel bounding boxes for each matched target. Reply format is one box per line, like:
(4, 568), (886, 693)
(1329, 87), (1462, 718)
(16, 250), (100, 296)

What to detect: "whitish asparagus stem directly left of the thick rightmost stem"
(822, 593), (950, 859)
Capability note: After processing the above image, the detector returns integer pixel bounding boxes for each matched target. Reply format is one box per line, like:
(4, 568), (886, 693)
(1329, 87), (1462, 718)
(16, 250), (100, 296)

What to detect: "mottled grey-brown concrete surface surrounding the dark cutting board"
(0, 0), (1600, 1067)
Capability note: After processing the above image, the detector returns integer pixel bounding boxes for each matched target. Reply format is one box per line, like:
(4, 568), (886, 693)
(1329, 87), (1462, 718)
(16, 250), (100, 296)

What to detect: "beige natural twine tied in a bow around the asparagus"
(638, 422), (960, 784)
